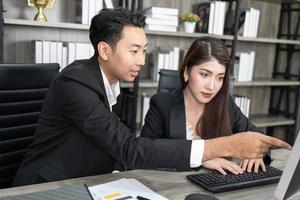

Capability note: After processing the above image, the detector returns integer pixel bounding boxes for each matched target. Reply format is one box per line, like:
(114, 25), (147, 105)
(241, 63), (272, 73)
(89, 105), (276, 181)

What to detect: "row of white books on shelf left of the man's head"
(33, 40), (94, 69)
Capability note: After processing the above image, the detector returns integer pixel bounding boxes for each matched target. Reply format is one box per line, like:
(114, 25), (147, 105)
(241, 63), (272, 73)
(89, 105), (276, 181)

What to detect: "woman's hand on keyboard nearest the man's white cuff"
(202, 158), (243, 175)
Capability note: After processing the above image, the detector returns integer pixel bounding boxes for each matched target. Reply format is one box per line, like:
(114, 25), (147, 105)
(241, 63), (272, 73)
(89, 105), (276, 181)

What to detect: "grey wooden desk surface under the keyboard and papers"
(0, 149), (289, 200)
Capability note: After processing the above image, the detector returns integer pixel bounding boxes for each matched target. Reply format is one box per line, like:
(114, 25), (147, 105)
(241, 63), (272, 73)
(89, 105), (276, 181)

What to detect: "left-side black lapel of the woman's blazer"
(170, 88), (186, 139)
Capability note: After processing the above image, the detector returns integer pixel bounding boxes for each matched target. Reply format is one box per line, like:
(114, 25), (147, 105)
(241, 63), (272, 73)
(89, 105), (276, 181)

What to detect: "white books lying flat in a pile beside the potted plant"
(145, 7), (179, 32)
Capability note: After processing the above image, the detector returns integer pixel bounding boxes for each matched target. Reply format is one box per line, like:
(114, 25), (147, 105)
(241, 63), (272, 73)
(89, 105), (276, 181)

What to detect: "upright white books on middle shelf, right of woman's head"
(234, 51), (255, 81)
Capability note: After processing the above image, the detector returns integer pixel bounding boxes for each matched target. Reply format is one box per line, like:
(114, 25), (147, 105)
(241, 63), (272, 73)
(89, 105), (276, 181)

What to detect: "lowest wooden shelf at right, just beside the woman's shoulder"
(250, 114), (295, 128)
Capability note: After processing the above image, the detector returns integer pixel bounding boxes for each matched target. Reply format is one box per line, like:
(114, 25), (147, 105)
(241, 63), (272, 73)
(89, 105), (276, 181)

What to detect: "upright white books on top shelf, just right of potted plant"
(208, 1), (226, 35)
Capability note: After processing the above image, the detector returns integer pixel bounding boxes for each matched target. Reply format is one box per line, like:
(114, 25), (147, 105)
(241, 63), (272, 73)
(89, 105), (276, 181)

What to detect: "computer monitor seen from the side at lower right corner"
(274, 131), (300, 200)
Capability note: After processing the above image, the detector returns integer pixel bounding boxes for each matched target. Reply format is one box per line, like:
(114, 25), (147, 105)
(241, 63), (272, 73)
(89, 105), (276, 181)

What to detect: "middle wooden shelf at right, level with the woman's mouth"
(233, 78), (300, 87)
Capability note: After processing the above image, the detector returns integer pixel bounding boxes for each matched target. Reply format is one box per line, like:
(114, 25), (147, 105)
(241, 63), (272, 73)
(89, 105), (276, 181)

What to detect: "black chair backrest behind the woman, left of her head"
(157, 69), (181, 92)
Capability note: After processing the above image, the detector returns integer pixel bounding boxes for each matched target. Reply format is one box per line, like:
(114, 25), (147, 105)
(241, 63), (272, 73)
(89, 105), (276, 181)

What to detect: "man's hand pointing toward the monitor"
(203, 131), (292, 161)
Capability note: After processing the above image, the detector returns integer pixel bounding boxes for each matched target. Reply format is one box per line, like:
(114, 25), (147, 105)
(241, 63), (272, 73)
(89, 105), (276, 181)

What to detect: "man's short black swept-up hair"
(90, 8), (146, 55)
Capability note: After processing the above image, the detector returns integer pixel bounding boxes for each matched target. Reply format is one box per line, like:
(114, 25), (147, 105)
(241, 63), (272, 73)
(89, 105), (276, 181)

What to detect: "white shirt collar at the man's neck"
(100, 66), (120, 111)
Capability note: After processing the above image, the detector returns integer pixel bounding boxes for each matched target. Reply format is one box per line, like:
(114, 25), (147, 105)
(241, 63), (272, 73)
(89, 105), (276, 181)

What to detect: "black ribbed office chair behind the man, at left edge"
(0, 64), (59, 188)
